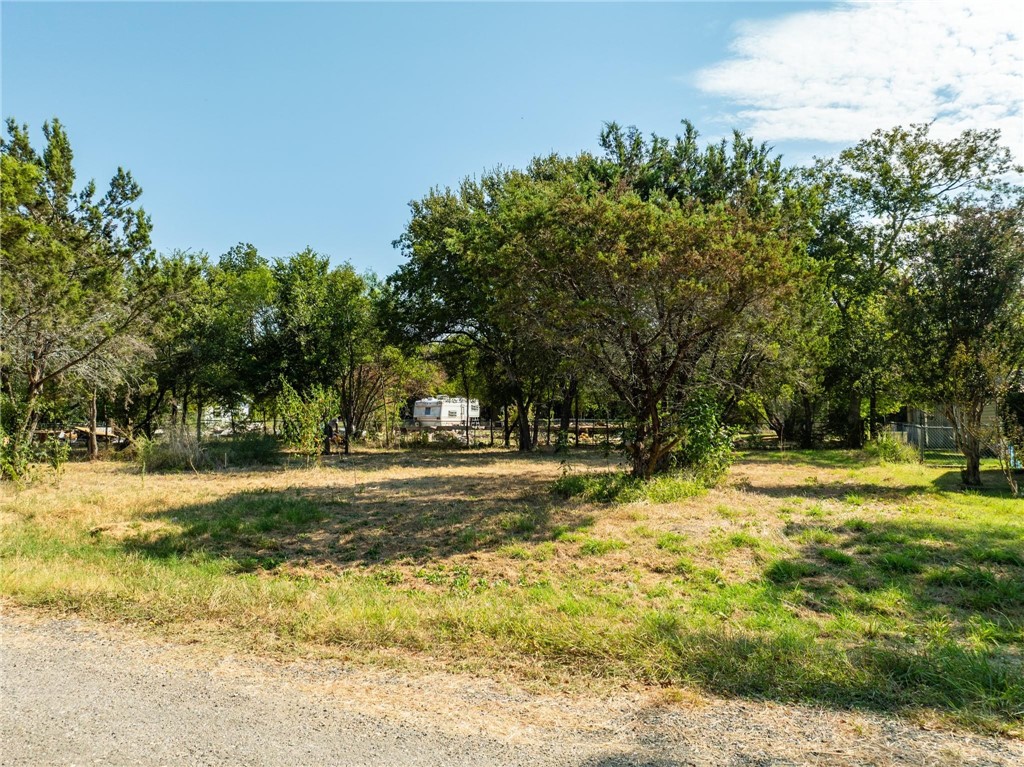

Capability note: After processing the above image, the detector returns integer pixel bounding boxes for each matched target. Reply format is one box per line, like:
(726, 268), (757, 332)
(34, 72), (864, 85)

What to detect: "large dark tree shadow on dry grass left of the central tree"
(121, 453), (593, 570)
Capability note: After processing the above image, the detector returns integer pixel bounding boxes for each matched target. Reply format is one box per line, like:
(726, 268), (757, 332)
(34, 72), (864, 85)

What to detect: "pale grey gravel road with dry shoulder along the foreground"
(0, 607), (1024, 767)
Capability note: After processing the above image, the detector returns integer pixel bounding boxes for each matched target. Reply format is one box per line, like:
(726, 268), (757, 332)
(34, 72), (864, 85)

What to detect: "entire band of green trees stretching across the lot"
(0, 119), (1024, 484)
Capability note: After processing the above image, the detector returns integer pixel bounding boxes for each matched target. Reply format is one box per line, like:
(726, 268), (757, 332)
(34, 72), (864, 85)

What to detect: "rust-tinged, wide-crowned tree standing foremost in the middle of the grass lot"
(535, 184), (799, 478)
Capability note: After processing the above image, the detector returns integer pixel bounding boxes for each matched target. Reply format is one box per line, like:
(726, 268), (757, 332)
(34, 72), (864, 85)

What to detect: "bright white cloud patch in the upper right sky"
(696, 0), (1024, 161)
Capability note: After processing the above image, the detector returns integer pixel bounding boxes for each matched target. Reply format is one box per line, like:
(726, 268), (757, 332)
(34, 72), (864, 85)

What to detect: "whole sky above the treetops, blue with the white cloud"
(0, 1), (1024, 274)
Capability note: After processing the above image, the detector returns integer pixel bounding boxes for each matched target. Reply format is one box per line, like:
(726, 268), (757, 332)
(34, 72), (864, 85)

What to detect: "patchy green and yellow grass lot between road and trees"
(0, 451), (1024, 736)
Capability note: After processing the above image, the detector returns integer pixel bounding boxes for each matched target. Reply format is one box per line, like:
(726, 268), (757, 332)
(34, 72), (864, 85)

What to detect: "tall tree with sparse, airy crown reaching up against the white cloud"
(811, 125), (1013, 448)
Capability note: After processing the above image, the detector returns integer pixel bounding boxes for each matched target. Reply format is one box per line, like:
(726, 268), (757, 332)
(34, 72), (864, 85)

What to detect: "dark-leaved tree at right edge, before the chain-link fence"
(897, 203), (1024, 485)
